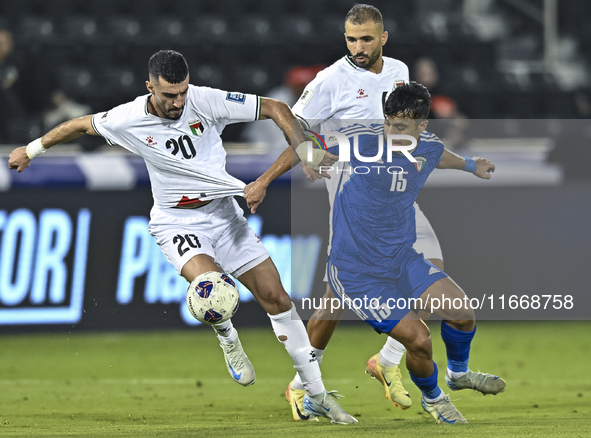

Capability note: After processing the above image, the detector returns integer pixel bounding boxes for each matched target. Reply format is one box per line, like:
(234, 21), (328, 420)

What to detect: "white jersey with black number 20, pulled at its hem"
(92, 85), (260, 208)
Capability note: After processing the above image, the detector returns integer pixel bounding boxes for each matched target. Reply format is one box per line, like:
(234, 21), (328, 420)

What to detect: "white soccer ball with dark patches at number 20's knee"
(187, 271), (240, 324)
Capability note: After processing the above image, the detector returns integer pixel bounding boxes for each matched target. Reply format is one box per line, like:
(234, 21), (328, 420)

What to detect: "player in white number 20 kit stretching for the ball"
(8, 50), (357, 423)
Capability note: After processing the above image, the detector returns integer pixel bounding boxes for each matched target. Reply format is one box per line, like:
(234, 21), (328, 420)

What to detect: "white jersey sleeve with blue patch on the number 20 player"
(200, 88), (261, 125)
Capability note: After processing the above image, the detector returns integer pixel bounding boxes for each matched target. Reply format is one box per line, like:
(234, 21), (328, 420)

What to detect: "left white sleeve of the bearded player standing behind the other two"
(292, 76), (336, 129)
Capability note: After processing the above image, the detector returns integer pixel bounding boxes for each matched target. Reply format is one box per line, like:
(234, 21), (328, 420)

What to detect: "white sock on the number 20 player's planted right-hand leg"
(269, 303), (324, 395)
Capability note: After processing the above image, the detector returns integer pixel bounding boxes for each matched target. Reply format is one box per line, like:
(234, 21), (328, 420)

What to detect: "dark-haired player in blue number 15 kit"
(327, 82), (505, 423)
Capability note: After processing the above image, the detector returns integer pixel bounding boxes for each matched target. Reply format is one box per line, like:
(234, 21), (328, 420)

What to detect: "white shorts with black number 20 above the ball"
(148, 197), (269, 278)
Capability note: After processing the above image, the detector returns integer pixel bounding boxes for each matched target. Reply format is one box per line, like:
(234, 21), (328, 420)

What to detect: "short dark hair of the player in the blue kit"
(384, 81), (431, 120)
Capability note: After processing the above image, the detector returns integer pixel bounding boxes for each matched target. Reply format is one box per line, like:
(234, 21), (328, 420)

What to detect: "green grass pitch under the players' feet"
(0, 322), (591, 437)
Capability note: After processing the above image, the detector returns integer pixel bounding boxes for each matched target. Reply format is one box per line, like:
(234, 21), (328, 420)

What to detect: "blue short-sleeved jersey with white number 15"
(329, 125), (444, 270)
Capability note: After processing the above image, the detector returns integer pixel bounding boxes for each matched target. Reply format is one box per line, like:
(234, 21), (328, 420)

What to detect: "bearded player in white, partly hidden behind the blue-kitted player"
(246, 4), (494, 420)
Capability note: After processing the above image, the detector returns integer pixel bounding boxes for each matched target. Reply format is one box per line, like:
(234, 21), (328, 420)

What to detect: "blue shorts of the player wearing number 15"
(327, 245), (447, 333)
